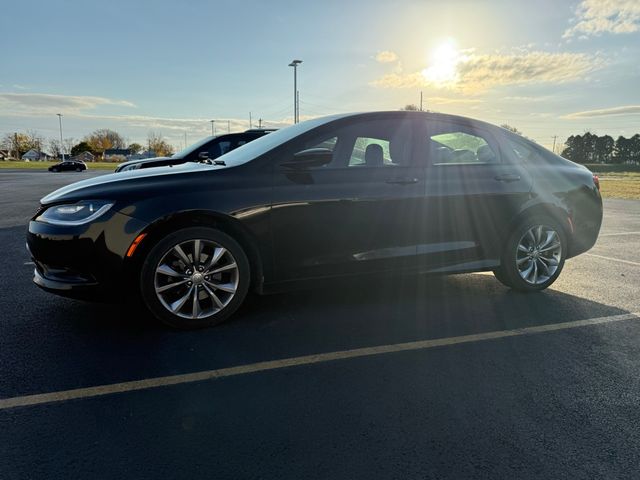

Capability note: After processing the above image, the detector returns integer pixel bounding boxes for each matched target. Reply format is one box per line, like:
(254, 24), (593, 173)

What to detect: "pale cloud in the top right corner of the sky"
(562, 0), (640, 38)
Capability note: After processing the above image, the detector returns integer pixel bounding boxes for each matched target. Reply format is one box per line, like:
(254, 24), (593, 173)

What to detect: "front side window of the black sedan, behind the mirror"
(292, 117), (413, 168)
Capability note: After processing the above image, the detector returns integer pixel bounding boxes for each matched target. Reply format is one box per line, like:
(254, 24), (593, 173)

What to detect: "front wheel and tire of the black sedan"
(140, 227), (251, 329)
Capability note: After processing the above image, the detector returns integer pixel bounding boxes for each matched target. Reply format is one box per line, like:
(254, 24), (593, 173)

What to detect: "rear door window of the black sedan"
(428, 124), (500, 165)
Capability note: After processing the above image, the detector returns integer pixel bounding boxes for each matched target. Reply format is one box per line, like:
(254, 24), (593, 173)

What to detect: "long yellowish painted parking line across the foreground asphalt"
(0, 313), (640, 410)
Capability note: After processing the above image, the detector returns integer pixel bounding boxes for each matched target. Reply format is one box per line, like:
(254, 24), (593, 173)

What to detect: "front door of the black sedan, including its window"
(271, 117), (425, 280)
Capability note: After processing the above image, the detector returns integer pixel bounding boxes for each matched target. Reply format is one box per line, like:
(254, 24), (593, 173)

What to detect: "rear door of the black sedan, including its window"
(418, 117), (531, 271)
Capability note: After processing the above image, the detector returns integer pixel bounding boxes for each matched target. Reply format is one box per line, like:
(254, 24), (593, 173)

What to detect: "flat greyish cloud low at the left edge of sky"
(0, 93), (135, 115)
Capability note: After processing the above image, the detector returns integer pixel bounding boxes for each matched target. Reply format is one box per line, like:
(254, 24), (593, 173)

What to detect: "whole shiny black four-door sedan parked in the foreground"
(27, 112), (602, 328)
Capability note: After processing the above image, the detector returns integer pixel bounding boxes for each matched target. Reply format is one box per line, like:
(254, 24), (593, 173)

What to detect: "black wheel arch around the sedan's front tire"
(126, 210), (264, 291)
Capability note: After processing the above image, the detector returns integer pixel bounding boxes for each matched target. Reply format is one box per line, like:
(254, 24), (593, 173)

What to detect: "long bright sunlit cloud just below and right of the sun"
(372, 51), (603, 94)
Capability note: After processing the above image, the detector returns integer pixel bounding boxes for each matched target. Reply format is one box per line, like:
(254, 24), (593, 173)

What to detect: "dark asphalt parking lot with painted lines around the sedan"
(0, 171), (640, 479)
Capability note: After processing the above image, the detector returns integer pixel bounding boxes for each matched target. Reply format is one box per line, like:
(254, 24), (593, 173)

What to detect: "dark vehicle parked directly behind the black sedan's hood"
(115, 128), (275, 173)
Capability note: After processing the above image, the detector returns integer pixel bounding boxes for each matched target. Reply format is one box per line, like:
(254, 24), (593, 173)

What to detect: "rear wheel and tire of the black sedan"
(493, 216), (568, 293)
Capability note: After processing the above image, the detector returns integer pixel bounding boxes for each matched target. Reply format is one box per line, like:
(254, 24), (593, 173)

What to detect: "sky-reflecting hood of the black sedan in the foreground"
(40, 162), (220, 205)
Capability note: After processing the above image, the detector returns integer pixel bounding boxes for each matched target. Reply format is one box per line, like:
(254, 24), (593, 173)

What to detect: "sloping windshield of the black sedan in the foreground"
(219, 115), (344, 166)
